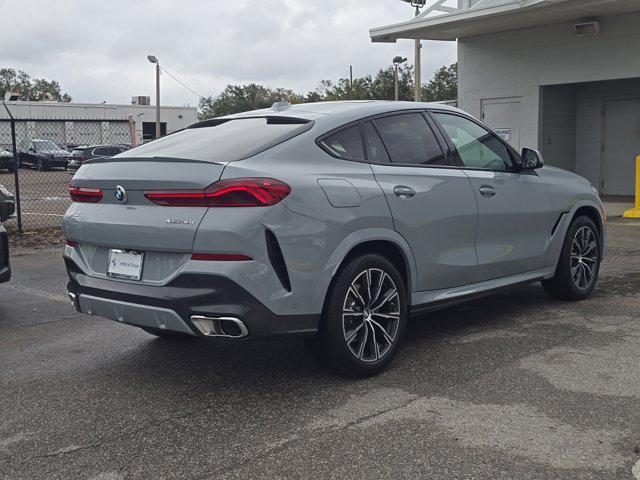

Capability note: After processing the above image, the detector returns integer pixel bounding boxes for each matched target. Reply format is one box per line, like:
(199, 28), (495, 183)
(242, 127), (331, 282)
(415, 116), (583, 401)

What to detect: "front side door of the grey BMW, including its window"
(432, 111), (554, 281)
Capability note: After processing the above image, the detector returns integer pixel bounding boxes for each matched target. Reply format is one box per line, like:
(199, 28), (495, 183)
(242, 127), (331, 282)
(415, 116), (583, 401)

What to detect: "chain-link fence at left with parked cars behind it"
(0, 111), (131, 231)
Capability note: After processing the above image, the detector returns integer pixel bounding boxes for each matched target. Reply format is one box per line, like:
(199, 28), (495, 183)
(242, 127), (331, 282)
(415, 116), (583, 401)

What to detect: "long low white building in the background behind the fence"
(0, 97), (198, 146)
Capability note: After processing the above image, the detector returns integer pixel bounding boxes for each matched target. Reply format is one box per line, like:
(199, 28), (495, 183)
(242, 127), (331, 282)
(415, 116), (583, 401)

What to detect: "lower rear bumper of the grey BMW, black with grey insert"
(65, 257), (319, 339)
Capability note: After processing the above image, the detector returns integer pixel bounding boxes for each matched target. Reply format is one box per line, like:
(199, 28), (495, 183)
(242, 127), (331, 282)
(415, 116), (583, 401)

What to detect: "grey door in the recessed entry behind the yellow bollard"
(602, 99), (640, 195)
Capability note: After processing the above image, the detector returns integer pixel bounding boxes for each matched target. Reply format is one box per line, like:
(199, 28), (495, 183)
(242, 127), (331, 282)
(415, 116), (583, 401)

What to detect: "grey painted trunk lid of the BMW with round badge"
(63, 158), (224, 255)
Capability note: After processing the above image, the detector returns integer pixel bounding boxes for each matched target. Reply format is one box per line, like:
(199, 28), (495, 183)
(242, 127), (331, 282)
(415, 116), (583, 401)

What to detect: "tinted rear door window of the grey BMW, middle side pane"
(374, 113), (447, 165)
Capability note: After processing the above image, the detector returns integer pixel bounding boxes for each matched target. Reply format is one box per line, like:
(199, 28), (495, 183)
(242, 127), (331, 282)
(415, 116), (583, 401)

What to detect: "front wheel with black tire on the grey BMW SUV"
(542, 215), (602, 302)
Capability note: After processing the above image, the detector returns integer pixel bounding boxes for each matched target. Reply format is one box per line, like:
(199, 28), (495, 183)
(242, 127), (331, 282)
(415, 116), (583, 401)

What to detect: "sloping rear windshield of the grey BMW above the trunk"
(116, 117), (312, 162)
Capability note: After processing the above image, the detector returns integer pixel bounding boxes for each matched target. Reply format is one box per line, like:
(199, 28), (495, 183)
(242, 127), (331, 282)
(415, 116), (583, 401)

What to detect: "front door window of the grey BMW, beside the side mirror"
(434, 112), (512, 172)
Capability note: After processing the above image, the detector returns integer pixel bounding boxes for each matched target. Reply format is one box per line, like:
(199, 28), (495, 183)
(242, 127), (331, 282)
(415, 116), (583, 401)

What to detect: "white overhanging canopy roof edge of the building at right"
(370, 0), (640, 43)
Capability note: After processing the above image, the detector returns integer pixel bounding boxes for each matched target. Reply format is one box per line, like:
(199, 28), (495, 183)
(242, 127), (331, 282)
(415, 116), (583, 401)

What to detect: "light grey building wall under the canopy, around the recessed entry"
(458, 12), (640, 155)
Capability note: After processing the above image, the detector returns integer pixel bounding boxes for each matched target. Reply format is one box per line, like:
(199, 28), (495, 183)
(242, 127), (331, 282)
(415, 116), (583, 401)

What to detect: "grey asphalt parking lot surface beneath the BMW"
(0, 221), (640, 480)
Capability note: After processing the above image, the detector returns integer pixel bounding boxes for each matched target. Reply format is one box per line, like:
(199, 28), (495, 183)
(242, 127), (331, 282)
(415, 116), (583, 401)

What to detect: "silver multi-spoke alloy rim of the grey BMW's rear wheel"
(342, 268), (401, 363)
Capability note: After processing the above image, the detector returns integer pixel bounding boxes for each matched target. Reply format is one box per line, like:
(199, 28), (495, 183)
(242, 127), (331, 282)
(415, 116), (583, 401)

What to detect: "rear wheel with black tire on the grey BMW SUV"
(307, 254), (407, 378)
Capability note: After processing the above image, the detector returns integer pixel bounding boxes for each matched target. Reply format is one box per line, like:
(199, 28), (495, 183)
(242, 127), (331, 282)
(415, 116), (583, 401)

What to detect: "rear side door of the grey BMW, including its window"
(362, 111), (477, 291)
